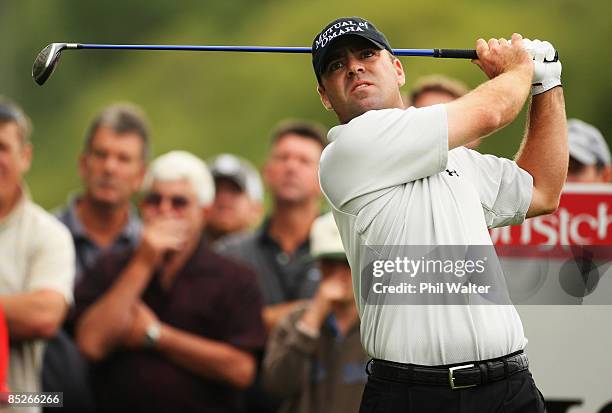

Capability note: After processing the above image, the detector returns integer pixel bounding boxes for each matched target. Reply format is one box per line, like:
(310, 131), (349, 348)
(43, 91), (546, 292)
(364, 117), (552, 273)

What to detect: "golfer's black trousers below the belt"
(359, 370), (544, 413)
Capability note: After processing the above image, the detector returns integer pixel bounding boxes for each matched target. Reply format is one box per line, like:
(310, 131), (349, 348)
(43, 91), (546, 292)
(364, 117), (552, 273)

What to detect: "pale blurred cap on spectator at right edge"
(567, 119), (610, 165)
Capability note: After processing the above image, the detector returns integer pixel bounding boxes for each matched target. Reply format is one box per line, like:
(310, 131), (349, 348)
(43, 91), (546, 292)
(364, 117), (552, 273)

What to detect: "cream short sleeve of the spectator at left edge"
(27, 216), (75, 304)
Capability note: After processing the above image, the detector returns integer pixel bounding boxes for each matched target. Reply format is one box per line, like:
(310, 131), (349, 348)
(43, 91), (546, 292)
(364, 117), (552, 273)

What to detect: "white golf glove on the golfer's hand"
(523, 39), (561, 96)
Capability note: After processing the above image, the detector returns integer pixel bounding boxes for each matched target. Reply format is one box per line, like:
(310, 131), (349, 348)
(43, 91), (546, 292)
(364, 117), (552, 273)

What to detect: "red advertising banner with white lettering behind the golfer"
(491, 184), (612, 258)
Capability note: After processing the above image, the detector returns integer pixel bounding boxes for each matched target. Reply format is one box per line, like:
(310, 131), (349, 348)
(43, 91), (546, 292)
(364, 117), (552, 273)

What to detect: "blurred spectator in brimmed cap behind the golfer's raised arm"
(406, 75), (482, 149)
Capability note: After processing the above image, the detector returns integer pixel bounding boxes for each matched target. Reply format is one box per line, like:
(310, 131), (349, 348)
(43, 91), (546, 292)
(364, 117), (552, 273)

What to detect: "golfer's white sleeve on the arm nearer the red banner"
(457, 148), (533, 228)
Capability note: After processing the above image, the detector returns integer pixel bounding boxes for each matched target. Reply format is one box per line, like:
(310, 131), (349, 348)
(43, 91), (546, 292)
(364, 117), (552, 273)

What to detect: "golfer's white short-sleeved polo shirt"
(319, 105), (533, 365)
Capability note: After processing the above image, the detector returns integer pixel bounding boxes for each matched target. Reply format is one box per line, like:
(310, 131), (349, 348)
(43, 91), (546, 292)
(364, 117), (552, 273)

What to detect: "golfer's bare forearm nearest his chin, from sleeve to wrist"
(446, 69), (531, 149)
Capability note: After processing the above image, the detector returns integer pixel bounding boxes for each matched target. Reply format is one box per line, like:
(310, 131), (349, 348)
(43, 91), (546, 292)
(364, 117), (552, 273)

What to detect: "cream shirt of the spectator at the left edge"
(0, 196), (75, 413)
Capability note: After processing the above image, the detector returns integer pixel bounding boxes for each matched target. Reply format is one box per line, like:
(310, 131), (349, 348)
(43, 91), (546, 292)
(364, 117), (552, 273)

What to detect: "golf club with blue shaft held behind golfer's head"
(32, 43), (478, 86)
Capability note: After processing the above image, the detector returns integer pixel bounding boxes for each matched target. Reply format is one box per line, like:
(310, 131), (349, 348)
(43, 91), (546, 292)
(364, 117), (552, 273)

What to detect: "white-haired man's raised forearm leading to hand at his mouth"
(76, 256), (151, 360)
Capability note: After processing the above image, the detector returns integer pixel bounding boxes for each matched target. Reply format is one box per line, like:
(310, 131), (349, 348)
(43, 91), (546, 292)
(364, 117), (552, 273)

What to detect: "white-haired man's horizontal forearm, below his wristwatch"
(157, 324), (255, 388)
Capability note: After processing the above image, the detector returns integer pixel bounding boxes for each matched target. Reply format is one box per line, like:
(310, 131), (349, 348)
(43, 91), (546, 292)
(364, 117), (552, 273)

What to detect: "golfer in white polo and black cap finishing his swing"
(312, 17), (568, 413)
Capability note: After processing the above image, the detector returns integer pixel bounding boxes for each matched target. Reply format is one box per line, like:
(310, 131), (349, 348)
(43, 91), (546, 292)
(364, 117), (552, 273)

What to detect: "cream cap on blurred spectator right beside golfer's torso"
(310, 212), (346, 260)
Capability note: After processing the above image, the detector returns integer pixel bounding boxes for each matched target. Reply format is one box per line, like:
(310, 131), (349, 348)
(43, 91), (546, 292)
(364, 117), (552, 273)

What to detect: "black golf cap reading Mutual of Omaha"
(312, 17), (393, 83)
